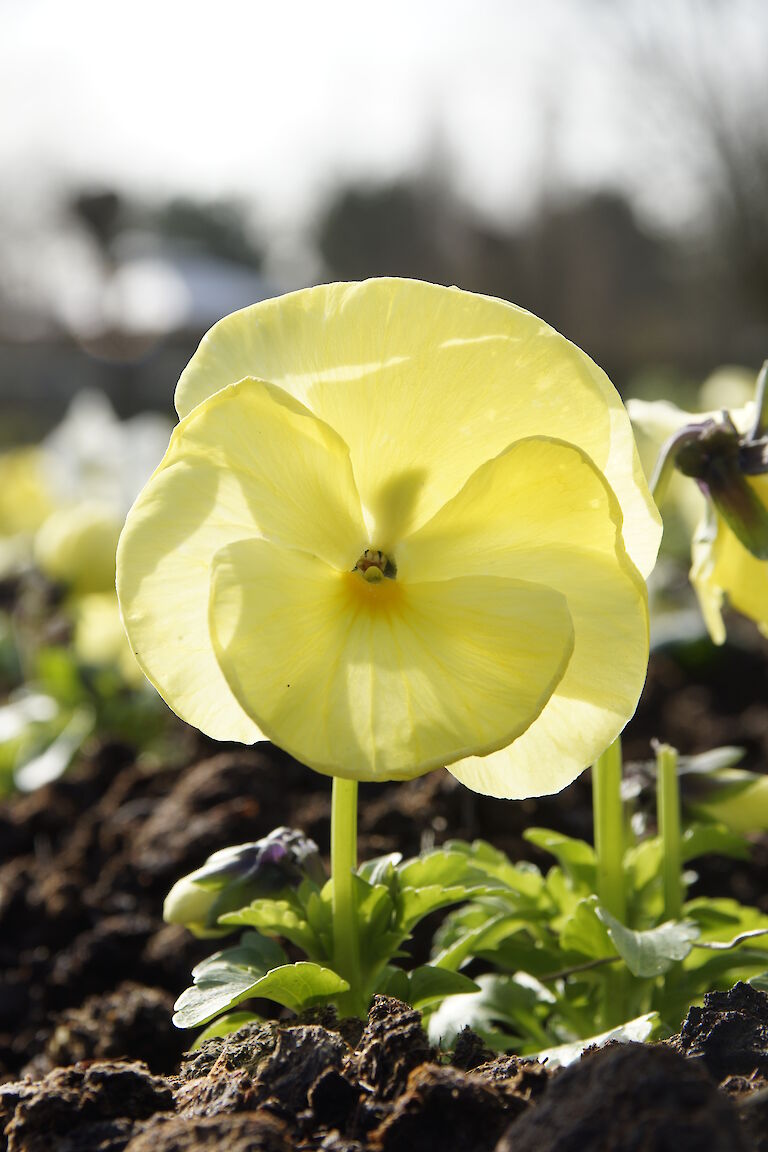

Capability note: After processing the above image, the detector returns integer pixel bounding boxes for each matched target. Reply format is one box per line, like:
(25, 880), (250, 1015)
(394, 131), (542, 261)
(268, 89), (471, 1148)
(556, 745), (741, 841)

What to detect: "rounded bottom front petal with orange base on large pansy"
(211, 540), (572, 780)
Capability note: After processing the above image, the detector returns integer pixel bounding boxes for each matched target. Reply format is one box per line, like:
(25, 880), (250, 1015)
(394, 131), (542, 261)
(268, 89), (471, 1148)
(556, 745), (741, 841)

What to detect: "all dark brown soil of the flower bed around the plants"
(0, 645), (768, 1152)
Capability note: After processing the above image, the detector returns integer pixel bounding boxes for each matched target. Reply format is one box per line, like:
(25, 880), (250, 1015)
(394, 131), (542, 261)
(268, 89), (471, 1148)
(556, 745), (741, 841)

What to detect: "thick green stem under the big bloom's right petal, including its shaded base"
(592, 737), (628, 1029)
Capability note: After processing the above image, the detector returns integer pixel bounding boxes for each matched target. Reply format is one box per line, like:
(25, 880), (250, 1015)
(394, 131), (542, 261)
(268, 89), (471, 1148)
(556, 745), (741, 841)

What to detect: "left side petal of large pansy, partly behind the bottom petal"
(117, 380), (367, 743)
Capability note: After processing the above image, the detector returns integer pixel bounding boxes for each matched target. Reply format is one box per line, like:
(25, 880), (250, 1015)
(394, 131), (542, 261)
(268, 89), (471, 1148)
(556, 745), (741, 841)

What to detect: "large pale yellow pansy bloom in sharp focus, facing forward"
(117, 279), (661, 797)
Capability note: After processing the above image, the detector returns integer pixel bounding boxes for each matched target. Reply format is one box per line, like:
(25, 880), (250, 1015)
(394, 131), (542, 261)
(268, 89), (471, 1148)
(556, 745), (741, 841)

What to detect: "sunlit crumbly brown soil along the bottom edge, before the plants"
(0, 986), (768, 1152)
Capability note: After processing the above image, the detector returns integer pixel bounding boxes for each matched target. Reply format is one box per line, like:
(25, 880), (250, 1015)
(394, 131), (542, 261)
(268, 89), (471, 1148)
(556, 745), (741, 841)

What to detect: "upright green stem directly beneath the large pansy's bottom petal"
(330, 776), (367, 1015)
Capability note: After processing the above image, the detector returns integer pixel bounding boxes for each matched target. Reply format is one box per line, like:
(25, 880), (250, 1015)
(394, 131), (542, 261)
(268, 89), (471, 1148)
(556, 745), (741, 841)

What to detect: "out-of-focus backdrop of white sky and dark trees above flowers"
(0, 0), (768, 445)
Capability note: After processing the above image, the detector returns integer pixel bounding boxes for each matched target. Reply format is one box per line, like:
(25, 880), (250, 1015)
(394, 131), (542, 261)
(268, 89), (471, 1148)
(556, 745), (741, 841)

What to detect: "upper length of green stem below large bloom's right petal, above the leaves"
(592, 738), (626, 924)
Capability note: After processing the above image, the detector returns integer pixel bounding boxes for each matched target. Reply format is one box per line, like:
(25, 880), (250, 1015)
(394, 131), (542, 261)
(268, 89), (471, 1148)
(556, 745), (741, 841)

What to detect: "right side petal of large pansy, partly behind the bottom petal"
(397, 438), (648, 798)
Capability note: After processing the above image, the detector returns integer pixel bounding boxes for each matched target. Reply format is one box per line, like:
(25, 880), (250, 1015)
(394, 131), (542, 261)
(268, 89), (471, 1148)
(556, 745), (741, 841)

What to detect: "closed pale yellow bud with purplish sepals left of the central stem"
(162, 827), (326, 937)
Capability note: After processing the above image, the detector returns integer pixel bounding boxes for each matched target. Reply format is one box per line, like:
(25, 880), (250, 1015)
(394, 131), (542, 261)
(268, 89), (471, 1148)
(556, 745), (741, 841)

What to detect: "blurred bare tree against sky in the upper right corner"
(622, 0), (768, 322)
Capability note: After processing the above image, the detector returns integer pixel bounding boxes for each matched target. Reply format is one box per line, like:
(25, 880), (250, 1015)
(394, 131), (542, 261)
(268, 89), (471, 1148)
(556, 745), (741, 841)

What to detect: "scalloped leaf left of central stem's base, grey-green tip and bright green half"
(174, 961), (349, 1028)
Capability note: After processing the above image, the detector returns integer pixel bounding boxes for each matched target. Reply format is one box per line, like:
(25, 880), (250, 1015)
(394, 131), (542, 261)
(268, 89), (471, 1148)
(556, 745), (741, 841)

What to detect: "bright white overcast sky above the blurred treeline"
(0, 0), (768, 235)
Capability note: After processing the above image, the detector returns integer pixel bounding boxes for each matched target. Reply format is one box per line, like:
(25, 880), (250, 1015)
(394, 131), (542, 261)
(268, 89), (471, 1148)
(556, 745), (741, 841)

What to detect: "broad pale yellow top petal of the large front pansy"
(176, 279), (661, 574)
